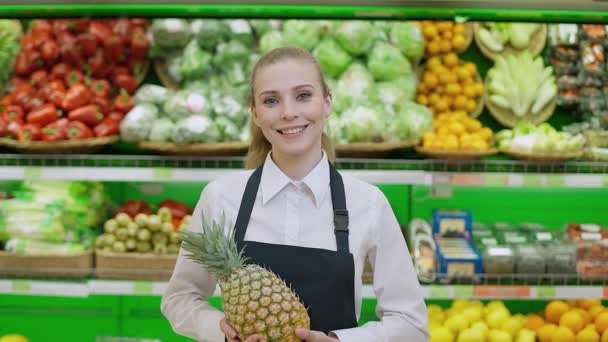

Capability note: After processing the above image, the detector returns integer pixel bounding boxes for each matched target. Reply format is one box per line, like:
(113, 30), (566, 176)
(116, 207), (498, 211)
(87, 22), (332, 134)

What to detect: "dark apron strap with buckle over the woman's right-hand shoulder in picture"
(329, 163), (350, 253)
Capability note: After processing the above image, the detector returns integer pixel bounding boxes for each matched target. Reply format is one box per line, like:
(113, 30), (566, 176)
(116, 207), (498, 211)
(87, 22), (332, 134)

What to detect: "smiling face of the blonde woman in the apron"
(252, 59), (331, 157)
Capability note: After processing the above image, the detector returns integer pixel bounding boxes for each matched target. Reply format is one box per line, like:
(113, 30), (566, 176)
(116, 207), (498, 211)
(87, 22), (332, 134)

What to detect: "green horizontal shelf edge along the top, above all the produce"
(0, 3), (608, 23)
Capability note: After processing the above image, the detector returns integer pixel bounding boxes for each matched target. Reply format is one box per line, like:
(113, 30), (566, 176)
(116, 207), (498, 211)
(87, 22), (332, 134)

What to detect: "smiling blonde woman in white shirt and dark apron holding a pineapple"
(162, 48), (428, 342)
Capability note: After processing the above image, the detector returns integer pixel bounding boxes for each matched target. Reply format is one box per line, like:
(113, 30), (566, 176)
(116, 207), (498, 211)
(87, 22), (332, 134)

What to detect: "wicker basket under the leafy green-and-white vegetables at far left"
(0, 251), (93, 278)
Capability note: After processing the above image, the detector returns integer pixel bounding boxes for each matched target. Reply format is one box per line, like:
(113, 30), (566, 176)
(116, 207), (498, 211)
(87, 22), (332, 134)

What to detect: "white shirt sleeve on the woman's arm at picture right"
(334, 190), (429, 342)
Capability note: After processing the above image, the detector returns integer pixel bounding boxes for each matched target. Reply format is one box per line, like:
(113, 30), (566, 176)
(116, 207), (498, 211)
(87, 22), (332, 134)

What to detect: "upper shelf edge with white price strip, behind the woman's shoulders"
(0, 155), (608, 188)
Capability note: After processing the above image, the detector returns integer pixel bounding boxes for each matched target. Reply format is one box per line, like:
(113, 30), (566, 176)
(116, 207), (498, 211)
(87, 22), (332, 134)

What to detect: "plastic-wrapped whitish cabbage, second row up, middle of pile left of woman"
(163, 90), (211, 122)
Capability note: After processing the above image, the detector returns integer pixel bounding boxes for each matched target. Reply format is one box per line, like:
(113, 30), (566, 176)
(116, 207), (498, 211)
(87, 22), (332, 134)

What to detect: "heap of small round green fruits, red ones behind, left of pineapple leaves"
(95, 201), (190, 254)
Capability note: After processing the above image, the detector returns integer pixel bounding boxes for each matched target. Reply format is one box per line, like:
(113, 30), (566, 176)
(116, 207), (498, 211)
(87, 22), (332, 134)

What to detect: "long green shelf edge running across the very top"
(0, 0), (608, 23)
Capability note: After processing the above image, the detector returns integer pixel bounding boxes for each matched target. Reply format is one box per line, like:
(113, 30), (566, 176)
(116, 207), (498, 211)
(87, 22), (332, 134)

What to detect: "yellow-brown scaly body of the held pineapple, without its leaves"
(219, 264), (310, 342)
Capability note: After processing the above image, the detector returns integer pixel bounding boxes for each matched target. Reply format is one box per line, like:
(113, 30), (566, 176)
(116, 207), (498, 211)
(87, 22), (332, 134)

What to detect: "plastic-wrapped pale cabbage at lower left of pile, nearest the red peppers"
(120, 103), (158, 142)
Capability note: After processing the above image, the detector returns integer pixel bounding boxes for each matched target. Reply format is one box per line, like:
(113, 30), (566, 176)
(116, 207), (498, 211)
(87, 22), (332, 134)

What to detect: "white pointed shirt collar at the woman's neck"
(260, 151), (329, 208)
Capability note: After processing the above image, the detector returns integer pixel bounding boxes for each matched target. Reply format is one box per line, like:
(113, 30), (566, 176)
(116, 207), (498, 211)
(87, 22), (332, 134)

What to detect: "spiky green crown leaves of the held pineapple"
(179, 214), (247, 281)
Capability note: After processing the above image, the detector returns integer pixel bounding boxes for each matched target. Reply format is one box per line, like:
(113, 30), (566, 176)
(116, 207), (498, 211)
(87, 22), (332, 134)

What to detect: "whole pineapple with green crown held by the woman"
(181, 215), (310, 342)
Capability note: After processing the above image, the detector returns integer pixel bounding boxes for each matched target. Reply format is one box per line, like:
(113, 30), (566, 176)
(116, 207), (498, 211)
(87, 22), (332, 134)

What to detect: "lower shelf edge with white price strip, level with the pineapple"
(0, 279), (608, 299)
